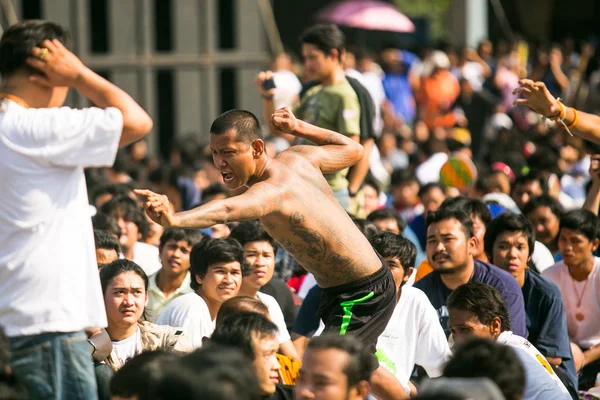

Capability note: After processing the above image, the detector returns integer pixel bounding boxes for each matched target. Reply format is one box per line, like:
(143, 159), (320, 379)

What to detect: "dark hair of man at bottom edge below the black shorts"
(306, 334), (377, 388)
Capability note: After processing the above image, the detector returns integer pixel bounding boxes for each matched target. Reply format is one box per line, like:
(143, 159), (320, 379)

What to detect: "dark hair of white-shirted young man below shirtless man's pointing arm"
(190, 237), (244, 290)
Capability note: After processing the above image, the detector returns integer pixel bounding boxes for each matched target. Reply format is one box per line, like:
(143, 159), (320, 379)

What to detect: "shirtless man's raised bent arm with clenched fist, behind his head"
(271, 107), (364, 174)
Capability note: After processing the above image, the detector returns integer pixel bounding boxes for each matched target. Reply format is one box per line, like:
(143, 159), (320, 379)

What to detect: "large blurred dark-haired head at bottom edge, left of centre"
(154, 344), (262, 400)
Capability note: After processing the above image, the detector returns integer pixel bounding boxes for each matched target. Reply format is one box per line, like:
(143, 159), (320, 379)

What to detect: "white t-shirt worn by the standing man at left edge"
(0, 100), (123, 336)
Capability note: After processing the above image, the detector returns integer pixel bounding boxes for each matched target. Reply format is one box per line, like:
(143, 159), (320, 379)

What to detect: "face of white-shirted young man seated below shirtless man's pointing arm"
(196, 261), (242, 303)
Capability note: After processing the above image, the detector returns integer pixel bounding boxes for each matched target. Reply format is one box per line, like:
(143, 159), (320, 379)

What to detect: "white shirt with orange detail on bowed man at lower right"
(497, 331), (571, 400)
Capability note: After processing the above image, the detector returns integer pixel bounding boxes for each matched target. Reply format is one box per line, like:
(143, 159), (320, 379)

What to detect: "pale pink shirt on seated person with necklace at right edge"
(542, 257), (600, 349)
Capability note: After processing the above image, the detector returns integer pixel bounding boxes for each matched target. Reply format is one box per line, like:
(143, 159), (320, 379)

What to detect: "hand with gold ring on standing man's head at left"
(27, 39), (87, 87)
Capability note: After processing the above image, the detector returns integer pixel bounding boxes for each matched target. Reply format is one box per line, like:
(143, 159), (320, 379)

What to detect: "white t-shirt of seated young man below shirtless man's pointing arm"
(156, 293), (215, 349)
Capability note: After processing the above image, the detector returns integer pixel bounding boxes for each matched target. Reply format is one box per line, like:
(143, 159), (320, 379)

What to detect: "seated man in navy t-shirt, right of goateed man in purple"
(485, 213), (577, 392)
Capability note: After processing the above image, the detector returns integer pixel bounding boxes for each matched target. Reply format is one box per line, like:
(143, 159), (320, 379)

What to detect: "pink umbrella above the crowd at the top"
(317, 0), (415, 32)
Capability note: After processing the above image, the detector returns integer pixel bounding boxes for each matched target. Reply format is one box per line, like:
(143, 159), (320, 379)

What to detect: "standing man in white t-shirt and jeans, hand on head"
(0, 20), (152, 400)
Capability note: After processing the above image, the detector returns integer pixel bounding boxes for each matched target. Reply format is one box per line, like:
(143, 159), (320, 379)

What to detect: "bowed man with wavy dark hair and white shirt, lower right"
(446, 282), (572, 400)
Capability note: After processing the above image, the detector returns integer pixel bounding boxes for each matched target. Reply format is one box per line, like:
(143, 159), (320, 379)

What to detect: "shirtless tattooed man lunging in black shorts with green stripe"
(136, 107), (406, 399)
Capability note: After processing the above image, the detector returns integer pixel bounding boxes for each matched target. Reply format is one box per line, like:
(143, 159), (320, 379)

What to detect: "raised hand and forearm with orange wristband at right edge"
(514, 79), (600, 143)
